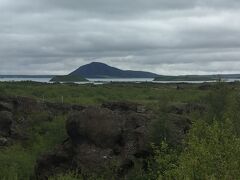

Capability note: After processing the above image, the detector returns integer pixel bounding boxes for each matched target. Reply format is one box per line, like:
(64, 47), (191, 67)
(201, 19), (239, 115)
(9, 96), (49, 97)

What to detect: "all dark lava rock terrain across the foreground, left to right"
(0, 97), (204, 179)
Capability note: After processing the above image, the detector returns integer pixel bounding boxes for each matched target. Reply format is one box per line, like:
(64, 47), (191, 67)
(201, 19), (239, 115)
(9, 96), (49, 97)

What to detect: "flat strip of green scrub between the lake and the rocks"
(0, 82), (207, 107)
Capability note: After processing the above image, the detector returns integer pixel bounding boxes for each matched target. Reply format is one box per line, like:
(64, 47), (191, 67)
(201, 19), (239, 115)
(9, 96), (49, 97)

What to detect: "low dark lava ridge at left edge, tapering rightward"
(0, 96), (84, 146)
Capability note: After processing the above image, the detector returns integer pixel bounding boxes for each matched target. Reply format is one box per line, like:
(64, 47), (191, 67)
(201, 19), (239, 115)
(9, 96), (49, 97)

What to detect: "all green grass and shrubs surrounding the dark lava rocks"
(0, 82), (240, 179)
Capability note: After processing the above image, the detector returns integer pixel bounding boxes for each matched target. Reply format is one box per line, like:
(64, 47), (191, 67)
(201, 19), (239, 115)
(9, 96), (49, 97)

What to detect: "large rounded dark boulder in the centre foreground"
(66, 107), (123, 147)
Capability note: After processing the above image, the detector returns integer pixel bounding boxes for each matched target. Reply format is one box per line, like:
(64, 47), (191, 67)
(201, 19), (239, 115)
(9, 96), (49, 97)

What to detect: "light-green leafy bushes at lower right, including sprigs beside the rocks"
(148, 119), (240, 180)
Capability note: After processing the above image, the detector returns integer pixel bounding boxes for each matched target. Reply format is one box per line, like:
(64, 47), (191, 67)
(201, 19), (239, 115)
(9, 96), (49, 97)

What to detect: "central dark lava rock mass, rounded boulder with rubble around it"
(36, 104), (150, 179)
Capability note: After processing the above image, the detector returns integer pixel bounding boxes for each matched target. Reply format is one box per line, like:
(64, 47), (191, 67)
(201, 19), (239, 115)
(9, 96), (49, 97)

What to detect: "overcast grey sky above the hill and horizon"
(0, 0), (240, 75)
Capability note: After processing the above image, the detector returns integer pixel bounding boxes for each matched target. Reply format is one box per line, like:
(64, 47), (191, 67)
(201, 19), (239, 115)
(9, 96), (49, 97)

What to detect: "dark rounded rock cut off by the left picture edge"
(0, 111), (13, 137)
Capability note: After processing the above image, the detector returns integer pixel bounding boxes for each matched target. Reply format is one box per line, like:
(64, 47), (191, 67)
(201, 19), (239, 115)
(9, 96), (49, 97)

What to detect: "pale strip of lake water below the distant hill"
(0, 78), (240, 84)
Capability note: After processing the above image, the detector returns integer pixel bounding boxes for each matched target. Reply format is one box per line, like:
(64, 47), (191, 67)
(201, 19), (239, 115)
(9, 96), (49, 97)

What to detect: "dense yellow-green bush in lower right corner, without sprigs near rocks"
(172, 120), (240, 179)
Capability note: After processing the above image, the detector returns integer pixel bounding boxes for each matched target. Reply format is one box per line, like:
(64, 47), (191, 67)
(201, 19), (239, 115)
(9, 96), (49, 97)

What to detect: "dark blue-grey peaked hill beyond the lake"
(70, 62), (158, 78)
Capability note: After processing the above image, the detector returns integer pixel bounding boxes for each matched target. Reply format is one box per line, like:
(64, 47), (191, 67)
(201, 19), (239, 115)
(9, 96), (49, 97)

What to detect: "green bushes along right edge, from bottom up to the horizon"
(150, 83), (240, 179)
